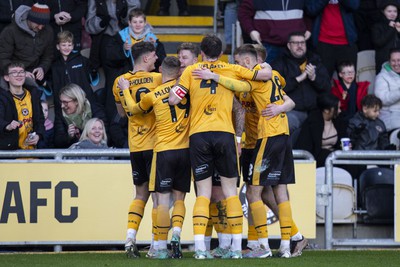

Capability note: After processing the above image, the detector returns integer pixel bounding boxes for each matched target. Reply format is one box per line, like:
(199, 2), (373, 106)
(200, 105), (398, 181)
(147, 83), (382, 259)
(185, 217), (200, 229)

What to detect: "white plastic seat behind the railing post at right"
(316, 167), (356, 223)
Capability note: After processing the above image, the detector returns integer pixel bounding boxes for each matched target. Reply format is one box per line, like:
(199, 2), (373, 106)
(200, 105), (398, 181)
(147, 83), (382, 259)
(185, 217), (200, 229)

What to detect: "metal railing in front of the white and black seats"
(325, 151), (400, 249)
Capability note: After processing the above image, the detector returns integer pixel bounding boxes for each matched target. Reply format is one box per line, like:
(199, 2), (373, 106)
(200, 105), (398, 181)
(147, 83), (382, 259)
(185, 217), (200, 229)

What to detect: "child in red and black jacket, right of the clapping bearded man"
(331, 61), (370, 136)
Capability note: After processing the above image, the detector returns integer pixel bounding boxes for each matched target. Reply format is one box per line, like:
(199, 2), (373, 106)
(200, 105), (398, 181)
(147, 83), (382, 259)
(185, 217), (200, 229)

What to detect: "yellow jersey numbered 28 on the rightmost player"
(251, 70), (289, 139)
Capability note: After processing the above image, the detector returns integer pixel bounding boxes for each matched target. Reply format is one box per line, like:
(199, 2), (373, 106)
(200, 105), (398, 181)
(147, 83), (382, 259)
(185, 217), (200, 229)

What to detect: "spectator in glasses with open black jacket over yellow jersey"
(0, 63), (45, 150)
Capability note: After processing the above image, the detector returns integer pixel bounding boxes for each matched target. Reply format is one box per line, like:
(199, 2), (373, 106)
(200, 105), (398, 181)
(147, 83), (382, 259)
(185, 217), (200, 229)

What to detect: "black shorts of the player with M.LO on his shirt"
(149, 148), (191, 193)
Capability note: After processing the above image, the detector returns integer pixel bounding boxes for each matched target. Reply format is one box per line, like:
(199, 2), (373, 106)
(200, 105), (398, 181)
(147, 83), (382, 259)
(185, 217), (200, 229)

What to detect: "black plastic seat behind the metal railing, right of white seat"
(360, 168), (394, 224)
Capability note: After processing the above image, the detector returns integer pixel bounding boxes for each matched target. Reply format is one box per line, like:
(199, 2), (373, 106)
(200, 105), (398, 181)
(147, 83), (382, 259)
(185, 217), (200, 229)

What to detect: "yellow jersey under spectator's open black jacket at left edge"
(13, 89), (35, 149)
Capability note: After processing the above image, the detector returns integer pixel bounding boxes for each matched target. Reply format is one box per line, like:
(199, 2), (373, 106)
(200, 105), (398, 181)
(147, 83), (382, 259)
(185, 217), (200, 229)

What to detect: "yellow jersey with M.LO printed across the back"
(139, 80), (190, 152)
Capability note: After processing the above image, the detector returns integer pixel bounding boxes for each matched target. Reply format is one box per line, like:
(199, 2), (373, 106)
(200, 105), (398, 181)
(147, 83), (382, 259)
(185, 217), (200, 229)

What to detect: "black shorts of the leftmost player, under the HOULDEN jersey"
(130, 150), (153, 185)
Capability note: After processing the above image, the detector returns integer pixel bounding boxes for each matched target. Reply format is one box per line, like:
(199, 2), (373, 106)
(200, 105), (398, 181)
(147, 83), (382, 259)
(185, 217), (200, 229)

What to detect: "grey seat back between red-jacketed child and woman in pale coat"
(356, 50), (376, 94)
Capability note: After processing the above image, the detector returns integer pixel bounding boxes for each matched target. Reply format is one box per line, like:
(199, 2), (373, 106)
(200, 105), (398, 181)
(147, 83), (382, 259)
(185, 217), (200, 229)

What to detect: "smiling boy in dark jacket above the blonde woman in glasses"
(51, 31), (98, 114)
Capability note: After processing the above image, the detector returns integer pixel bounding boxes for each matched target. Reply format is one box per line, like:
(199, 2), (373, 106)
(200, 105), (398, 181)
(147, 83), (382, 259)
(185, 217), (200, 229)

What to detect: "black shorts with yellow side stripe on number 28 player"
(247, 135), (295, 186)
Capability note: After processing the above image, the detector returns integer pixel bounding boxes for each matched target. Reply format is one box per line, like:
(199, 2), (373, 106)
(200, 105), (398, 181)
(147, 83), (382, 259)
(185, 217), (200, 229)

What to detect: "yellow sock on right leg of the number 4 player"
(226, 196), (243, 234)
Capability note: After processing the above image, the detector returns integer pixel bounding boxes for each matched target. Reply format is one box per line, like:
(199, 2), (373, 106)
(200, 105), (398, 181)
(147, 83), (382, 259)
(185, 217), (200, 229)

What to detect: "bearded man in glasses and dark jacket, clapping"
(271, 32), (331, 146)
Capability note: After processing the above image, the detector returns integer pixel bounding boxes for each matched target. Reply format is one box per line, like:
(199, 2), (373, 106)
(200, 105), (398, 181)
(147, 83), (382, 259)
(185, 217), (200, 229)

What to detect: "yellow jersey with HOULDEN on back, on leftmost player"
(113, 71), (162, 152)
